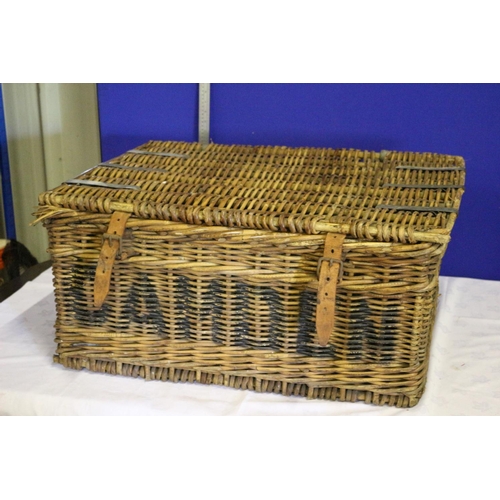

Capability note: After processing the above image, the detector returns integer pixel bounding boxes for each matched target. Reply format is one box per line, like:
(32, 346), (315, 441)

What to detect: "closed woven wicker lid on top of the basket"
(39, 141), (465, 243)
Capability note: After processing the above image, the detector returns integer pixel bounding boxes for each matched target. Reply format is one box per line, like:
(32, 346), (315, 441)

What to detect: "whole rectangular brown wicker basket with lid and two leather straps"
(37, 141), (465, 407)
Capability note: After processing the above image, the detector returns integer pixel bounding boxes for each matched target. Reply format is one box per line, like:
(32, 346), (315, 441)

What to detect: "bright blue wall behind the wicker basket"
(98, 84), (500, 280)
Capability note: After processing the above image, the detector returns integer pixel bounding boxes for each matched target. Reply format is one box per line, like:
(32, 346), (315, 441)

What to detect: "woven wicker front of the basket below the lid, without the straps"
(47, 213), (443, 404)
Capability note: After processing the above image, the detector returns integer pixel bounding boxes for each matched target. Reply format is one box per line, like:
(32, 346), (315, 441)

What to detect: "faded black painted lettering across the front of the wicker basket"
(66, 263), (401, 363)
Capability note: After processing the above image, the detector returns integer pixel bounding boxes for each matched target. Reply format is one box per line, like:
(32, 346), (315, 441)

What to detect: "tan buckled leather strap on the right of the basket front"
(316, 233), (345, 346)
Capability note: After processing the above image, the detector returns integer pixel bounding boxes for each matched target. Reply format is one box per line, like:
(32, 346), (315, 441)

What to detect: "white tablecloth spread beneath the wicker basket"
(0, 269), (500, 416)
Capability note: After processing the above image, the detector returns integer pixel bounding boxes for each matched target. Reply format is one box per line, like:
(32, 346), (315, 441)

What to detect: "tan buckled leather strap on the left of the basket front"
(94, 212), (130, 309)
